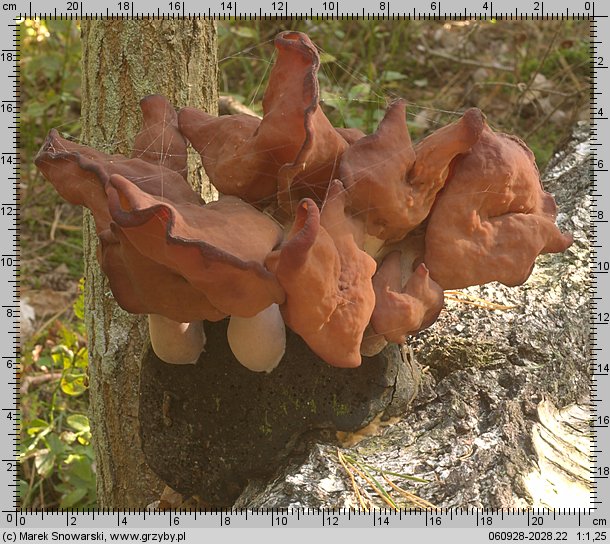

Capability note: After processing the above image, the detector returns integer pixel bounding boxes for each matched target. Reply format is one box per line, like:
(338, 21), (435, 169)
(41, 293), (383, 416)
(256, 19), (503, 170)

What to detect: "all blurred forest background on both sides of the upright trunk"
(20, 19), (591, 508)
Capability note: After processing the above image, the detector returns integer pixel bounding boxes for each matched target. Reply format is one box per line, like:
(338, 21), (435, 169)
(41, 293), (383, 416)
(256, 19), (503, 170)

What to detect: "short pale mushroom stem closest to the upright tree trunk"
(148, 314), (205, 365)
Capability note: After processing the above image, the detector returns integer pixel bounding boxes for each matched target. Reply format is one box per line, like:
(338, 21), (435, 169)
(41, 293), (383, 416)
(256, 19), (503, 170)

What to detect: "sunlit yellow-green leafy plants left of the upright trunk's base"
(19, 283), (96, 509)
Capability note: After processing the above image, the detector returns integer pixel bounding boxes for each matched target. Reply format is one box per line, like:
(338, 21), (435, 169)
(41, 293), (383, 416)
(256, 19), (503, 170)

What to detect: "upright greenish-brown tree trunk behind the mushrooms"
(82, 20), (217, 509)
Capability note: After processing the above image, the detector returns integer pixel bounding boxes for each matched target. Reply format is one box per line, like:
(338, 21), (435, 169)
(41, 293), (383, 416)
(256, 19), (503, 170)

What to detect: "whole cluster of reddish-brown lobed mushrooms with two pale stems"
(36, 32), (572, 371)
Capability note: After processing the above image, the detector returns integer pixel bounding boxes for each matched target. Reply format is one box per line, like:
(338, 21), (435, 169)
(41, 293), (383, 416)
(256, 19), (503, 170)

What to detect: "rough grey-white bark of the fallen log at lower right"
(235, 122), (592, 508)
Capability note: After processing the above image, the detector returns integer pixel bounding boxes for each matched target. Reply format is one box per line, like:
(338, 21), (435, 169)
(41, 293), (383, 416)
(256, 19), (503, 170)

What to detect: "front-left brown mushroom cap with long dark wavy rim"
(107, 175), (284, 321)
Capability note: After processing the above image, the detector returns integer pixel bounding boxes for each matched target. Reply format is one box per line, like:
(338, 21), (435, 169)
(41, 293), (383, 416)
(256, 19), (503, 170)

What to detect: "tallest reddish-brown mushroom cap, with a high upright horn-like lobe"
(178, 32), (350, 208)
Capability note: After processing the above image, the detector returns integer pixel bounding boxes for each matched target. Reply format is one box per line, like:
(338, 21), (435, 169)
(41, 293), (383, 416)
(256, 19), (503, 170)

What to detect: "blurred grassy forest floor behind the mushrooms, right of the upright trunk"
(219, 20), (590, 164)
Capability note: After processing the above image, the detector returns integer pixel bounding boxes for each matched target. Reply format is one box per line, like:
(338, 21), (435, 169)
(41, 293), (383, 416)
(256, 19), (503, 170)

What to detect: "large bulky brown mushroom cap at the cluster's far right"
(424, 119), (572, 289)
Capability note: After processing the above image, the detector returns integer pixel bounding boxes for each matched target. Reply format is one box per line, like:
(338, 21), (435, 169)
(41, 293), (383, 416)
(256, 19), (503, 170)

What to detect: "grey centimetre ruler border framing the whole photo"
(0, 0), (610, 542)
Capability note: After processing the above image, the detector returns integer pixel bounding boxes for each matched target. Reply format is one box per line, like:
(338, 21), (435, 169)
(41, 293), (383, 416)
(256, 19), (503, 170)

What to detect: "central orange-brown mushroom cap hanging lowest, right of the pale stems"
(267, 180), (376, 367)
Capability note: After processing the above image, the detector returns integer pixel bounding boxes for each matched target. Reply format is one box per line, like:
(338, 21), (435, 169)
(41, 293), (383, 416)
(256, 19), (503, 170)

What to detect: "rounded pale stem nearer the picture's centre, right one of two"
(227, 304), (286, 372)
